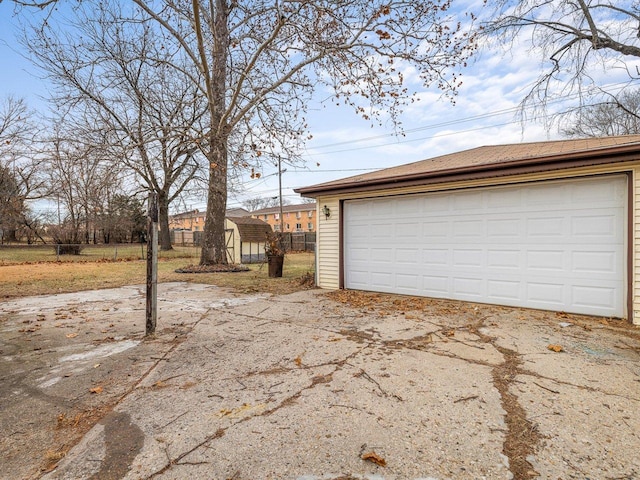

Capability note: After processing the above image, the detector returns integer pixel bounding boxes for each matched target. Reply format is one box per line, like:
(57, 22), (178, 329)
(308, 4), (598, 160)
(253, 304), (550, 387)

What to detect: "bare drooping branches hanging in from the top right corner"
(485, 0), (640, 122)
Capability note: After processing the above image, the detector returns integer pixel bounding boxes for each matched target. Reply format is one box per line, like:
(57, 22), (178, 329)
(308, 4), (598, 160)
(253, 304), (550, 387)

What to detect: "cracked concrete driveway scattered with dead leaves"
(0, 283), (640, 480)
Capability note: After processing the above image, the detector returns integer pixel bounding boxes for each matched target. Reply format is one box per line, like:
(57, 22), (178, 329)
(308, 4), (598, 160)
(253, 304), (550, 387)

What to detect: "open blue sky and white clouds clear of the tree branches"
(0, 1), (628, 213)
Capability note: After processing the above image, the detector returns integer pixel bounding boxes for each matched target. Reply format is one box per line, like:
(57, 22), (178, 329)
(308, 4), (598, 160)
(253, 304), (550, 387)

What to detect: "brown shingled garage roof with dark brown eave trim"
(295, 135), (640, 197)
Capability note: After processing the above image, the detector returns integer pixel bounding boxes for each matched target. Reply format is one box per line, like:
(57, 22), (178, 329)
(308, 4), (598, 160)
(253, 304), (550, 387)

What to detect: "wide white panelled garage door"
(344, 176), (627, 317)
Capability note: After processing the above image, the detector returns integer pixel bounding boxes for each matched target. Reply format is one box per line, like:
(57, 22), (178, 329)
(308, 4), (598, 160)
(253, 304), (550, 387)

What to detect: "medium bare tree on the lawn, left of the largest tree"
(25, 1), (207, 250)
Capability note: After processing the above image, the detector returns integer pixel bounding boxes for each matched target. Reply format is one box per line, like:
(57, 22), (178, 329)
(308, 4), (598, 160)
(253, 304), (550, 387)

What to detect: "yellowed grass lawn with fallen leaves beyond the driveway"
(0, 245), (315, 299)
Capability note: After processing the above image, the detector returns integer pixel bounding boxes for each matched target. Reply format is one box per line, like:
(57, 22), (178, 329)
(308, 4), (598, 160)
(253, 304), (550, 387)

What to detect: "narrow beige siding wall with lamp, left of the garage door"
(316, 197), (340, 290)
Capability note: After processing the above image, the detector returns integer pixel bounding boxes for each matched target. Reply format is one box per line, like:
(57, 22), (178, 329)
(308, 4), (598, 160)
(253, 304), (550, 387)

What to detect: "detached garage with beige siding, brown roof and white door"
(296, 135), (640, 324)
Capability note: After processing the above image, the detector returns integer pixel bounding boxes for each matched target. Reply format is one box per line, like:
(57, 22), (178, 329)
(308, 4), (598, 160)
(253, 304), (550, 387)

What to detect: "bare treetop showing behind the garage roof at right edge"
(561, 90), (640, 137)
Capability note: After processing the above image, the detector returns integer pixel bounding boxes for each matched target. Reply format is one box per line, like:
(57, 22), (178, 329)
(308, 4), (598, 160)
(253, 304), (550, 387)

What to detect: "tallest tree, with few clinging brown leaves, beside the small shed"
(126, 0), (475, 264)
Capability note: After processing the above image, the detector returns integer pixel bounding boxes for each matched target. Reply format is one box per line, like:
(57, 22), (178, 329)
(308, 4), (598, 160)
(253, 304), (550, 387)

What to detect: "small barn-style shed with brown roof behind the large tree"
(225, 217), (273, 264)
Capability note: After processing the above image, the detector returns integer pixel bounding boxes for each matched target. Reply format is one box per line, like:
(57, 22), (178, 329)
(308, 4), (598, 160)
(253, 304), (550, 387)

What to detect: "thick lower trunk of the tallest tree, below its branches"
(200, 133), (228, 265)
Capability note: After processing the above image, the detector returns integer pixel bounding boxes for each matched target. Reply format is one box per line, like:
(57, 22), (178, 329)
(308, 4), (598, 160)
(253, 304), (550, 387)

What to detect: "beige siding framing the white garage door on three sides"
(317, 162), (640, 324)
